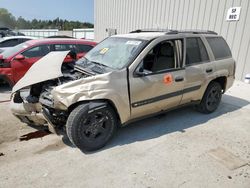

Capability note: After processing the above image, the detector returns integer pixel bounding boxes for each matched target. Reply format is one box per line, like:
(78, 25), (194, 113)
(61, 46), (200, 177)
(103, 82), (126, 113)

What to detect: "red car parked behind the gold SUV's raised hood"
(0, 38), (96, 86)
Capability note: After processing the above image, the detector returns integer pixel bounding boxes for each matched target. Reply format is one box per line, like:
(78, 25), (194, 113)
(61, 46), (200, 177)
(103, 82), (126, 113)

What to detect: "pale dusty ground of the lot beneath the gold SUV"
(0, 82), (250, 188)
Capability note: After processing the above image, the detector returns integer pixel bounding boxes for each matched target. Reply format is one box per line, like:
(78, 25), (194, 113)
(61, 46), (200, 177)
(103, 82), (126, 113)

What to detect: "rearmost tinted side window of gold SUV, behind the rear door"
(206, 37), (232, 60)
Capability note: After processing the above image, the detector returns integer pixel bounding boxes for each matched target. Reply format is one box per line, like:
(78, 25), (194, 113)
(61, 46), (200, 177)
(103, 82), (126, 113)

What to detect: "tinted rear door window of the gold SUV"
(186, 38), (209, 65)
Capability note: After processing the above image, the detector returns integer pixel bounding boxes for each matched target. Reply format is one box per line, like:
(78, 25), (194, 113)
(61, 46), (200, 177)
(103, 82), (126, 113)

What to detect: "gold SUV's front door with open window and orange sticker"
(129, 39), (185, 118)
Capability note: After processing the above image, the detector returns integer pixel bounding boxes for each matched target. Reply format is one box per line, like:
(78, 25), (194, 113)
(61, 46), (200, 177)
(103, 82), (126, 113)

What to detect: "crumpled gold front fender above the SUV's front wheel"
(51, 69), (130, 122)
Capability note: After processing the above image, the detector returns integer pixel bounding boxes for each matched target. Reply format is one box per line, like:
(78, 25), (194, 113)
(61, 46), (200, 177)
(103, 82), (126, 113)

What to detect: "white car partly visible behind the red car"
(0, 36), (37, 53)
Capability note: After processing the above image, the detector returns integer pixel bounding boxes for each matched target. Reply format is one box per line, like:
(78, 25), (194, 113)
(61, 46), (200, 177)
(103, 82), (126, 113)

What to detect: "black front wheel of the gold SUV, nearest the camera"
(66, 104), (117, 151)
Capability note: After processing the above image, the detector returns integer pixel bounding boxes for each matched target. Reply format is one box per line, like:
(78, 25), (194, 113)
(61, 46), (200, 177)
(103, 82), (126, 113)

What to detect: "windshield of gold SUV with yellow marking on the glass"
(85, 37), (146, 69)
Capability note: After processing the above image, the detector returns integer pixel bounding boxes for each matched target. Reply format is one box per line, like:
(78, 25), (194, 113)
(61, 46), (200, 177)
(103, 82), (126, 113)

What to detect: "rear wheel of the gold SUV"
(196, 82), (222, 114)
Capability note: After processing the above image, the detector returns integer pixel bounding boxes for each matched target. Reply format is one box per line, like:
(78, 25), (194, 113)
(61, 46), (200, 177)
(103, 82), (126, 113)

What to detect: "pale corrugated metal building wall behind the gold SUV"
(94, 0), (250, 79)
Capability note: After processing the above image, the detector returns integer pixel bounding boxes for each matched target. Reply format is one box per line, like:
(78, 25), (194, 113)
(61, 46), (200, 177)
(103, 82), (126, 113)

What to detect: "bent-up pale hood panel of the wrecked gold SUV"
(12, 51), (69, 93)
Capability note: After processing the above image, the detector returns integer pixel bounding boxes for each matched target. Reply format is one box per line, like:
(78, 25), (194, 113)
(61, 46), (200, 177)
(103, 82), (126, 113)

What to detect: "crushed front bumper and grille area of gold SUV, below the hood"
(11, 80), (71, 132)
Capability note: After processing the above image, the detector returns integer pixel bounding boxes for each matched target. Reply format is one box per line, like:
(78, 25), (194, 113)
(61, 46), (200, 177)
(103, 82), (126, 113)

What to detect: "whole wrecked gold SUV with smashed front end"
(11, 30), (235, 150)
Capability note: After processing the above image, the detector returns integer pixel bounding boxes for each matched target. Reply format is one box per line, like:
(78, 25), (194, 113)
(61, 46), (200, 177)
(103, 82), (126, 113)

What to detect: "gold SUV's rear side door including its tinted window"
(181, 37), (215, 104)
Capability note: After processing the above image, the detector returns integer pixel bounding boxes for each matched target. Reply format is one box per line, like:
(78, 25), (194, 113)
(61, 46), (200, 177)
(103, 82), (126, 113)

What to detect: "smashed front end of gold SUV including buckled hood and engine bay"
(11, 52), (109, 133)
